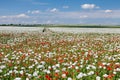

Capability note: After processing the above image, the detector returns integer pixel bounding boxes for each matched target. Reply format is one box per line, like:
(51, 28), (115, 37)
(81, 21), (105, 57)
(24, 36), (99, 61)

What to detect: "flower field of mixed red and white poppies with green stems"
(0, 32), (120, 80)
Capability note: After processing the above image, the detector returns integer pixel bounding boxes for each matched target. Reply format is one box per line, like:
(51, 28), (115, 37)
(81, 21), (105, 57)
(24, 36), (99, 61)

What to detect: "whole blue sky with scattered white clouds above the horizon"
(0, 0), (120, 25)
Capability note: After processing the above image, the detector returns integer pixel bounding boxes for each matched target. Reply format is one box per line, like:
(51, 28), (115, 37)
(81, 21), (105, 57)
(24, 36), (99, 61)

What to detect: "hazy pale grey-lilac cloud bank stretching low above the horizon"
(0, 8), (120, 24)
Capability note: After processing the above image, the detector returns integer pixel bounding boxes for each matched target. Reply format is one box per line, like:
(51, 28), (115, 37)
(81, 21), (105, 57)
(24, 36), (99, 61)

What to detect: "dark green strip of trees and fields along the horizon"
(0, 24), (120, 28)
